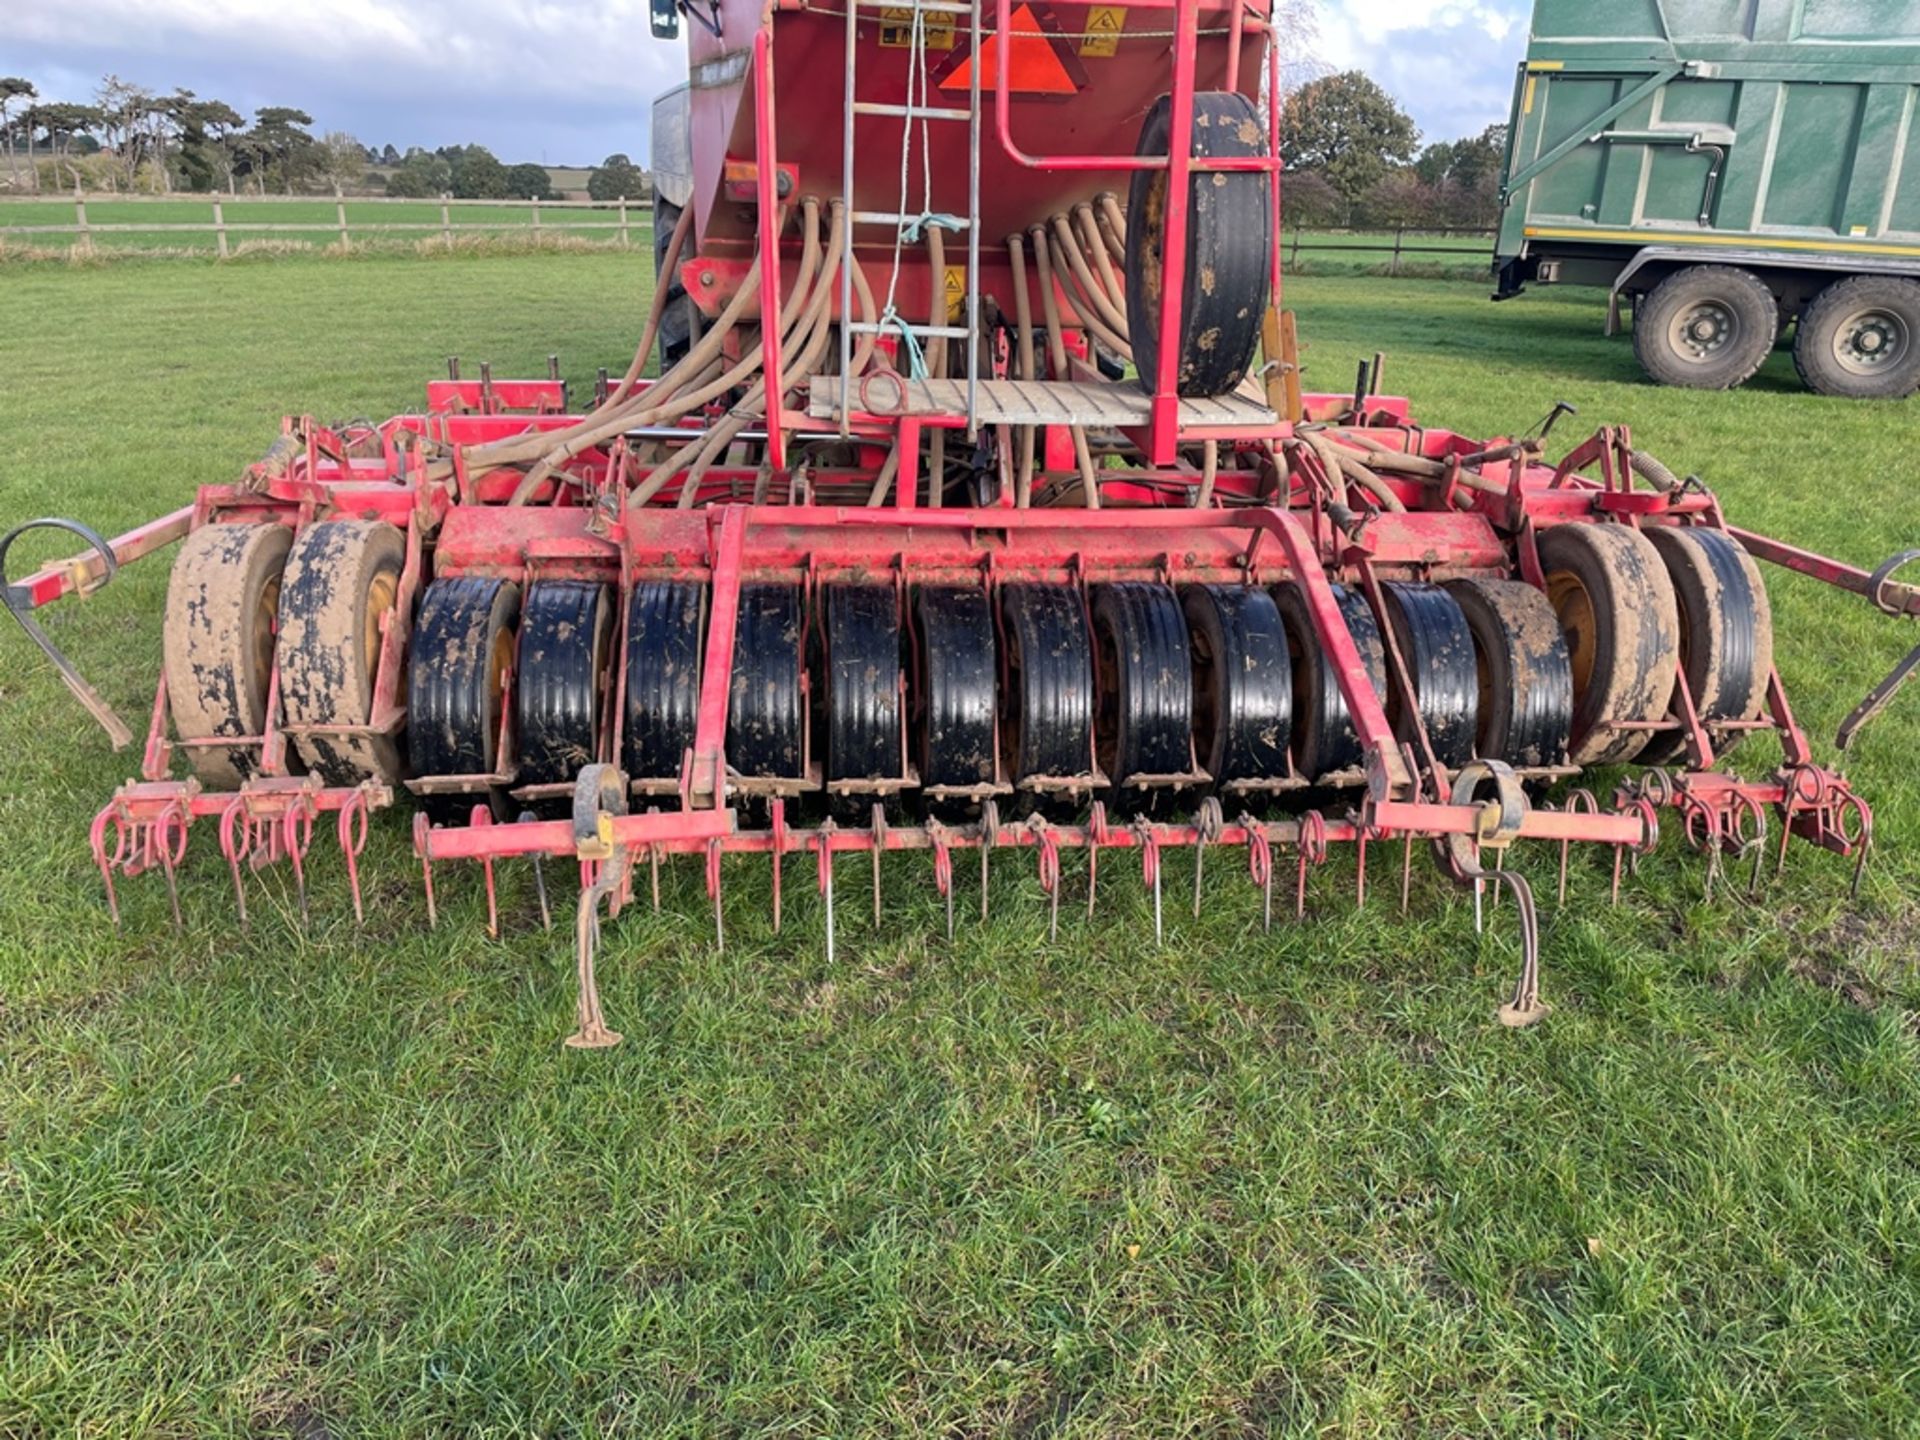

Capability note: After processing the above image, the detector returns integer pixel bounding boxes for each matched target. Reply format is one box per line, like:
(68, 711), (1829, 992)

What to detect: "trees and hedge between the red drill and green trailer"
(1281, 71), (1507, 230)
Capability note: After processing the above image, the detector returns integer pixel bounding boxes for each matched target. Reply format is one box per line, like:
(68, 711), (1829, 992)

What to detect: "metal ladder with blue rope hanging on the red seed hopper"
(839, 0), (987, 440)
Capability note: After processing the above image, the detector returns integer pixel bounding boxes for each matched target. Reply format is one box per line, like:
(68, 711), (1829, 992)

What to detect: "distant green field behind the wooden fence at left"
(0, 198), (653, 252)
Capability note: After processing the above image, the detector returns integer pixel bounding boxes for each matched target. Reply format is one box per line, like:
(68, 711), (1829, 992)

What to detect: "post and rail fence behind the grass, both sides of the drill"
(0, 194), (1496, 275)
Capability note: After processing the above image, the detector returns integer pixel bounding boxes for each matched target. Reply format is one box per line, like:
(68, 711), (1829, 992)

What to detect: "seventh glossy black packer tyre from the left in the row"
(1000, 584), (1092, 783)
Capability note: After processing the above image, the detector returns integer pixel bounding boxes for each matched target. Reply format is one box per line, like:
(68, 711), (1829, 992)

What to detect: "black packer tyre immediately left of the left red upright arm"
(622, 580), (707, 780)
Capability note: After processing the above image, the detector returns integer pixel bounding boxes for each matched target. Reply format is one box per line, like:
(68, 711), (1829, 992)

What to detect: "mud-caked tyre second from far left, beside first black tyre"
(280, 520), (407, 785)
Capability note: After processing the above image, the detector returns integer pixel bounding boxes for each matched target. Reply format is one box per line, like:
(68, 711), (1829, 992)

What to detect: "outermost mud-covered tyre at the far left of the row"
(161, 524), (294, 789)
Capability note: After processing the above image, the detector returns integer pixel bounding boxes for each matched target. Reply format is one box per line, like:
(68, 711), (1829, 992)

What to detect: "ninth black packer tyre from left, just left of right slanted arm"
(1185, 586), (1294, 785)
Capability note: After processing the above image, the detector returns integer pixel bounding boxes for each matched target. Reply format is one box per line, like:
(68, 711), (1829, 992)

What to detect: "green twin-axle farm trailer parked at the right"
(1494, 0), (1920, 397)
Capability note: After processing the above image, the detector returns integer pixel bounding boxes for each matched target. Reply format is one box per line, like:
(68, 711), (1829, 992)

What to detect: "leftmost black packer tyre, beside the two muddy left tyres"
(407, 576), (520, 826)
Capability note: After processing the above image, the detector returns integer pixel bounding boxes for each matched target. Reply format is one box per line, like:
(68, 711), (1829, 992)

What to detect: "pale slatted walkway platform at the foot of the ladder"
(808, 380), (1277, 430)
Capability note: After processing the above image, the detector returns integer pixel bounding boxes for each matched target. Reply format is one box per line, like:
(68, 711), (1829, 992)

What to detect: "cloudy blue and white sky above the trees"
(0, 0), (1528, 165)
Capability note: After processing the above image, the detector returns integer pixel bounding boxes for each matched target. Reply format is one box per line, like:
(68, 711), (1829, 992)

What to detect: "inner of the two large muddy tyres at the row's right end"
(1540, 522), (1680, 764)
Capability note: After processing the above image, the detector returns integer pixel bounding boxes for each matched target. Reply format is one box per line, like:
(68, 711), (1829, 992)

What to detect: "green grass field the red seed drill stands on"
(0, 253), (1920, 1440)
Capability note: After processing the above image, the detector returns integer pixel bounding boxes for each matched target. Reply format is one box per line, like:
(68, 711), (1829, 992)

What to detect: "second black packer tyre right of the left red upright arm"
(822, 586), (900, 780)
